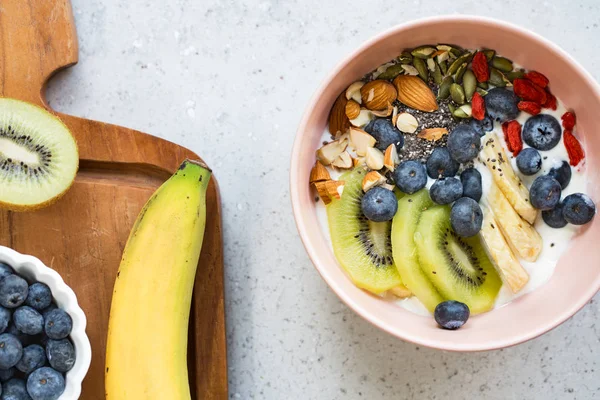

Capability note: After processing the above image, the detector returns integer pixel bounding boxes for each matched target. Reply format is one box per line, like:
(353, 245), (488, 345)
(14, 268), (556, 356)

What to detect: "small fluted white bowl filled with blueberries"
(0, 246), (92, 400)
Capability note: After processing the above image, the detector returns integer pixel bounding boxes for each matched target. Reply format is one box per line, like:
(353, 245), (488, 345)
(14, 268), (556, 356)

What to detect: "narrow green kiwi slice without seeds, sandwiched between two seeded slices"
(391, 189), (444, 313)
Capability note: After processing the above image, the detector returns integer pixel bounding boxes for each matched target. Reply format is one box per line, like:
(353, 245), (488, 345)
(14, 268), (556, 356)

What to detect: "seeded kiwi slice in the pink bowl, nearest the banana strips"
(414, 206), (502, 314)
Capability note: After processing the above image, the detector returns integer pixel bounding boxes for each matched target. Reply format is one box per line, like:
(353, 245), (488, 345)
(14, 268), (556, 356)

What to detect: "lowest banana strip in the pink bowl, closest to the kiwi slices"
(481, 207), (529, 293)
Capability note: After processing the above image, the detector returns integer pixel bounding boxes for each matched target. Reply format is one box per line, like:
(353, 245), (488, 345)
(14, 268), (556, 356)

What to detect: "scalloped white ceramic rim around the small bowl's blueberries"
(0, 246), (92, 400)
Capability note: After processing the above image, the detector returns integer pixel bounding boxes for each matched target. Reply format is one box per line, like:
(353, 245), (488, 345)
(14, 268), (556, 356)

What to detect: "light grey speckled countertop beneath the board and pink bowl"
(49, 0), (600, 400)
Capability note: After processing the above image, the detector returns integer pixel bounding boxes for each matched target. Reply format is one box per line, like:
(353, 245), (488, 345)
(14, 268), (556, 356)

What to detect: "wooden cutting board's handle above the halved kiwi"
(0, 0), (77, 106)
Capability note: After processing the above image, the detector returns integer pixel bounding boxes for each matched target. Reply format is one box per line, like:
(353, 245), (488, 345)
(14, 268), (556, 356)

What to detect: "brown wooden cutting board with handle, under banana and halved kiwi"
(0, 0), (228, 400)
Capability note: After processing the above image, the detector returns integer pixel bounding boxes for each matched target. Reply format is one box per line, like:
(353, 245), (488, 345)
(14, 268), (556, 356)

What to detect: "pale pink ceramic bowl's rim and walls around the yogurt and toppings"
(290, 16), (600, 351)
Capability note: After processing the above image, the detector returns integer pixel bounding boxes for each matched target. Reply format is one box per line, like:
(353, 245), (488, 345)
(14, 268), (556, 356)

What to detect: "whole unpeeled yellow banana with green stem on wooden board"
(105, 160), (211, 400)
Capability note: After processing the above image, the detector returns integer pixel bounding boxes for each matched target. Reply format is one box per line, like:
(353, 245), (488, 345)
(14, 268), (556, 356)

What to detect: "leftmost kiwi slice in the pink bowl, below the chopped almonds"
(327, 167), (402, 294)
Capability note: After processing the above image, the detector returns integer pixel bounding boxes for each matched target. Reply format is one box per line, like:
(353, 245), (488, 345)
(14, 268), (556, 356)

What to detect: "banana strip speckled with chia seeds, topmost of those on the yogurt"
(480, 133), (537, 224)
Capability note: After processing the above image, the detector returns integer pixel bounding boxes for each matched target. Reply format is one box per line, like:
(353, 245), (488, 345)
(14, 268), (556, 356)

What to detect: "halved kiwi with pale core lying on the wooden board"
(0, 98), (79, 211)
